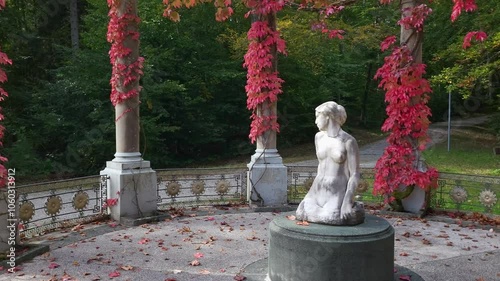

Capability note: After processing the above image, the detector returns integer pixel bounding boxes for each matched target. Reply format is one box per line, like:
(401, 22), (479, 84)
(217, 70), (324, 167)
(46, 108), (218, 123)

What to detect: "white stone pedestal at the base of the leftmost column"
(101, 153), (157, 222)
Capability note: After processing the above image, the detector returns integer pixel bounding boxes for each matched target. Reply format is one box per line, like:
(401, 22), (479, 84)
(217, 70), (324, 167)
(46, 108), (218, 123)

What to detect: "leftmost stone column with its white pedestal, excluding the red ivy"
(101, 0), (157, 221)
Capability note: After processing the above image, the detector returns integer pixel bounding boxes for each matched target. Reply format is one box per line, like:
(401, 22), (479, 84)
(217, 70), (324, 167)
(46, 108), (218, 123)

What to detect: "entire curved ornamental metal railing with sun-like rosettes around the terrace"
(16, 165), (500, 241)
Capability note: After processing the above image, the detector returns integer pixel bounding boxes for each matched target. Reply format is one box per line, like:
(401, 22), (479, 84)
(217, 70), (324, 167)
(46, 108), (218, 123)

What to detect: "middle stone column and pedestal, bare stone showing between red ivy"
(247, 14), (287, 207)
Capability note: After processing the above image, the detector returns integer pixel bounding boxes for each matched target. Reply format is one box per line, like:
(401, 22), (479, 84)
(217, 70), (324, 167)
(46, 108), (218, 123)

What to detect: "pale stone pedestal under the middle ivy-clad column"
(247, 149), (287, 206)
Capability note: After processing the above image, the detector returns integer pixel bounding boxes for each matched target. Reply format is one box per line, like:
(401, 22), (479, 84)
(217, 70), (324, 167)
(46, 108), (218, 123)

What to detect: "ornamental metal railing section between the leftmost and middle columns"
(156, 168), (247, 209)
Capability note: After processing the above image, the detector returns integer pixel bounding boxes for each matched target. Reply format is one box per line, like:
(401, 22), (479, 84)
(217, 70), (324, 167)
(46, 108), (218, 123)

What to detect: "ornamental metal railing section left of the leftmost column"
(16, 175), (108, 238)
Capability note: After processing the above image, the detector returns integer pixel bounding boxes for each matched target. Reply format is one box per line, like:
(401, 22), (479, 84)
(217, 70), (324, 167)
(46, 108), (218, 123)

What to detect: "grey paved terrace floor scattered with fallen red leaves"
(0, 207), (500, 281)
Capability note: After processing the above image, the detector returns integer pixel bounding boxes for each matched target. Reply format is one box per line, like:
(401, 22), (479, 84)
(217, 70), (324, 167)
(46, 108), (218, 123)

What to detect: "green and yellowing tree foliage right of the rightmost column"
(424, 0), (500, 120)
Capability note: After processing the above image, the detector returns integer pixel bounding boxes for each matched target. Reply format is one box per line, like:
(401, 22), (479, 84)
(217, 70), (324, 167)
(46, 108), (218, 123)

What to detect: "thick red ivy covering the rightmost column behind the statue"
(373, 1), (438, 201)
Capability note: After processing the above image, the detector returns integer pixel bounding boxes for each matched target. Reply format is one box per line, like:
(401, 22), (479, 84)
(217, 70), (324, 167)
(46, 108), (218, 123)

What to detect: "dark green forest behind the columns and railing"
(0, 0), (500, 179)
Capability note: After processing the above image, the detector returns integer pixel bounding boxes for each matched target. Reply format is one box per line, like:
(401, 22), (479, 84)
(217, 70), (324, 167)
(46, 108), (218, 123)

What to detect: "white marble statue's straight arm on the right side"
(340, 138), (360, 219)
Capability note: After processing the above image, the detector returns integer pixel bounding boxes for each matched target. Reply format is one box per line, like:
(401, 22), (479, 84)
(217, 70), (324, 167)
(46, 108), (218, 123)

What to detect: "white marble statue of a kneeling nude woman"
(296, 101), (364, 225)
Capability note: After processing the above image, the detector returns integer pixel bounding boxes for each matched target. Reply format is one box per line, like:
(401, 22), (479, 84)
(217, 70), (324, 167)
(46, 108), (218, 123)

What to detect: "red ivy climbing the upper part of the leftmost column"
(107, 0), (144, 106)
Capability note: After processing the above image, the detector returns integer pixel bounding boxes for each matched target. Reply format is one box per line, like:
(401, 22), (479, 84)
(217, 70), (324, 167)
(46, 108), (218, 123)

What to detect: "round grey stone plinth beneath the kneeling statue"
(266, 215), (394, 281)
